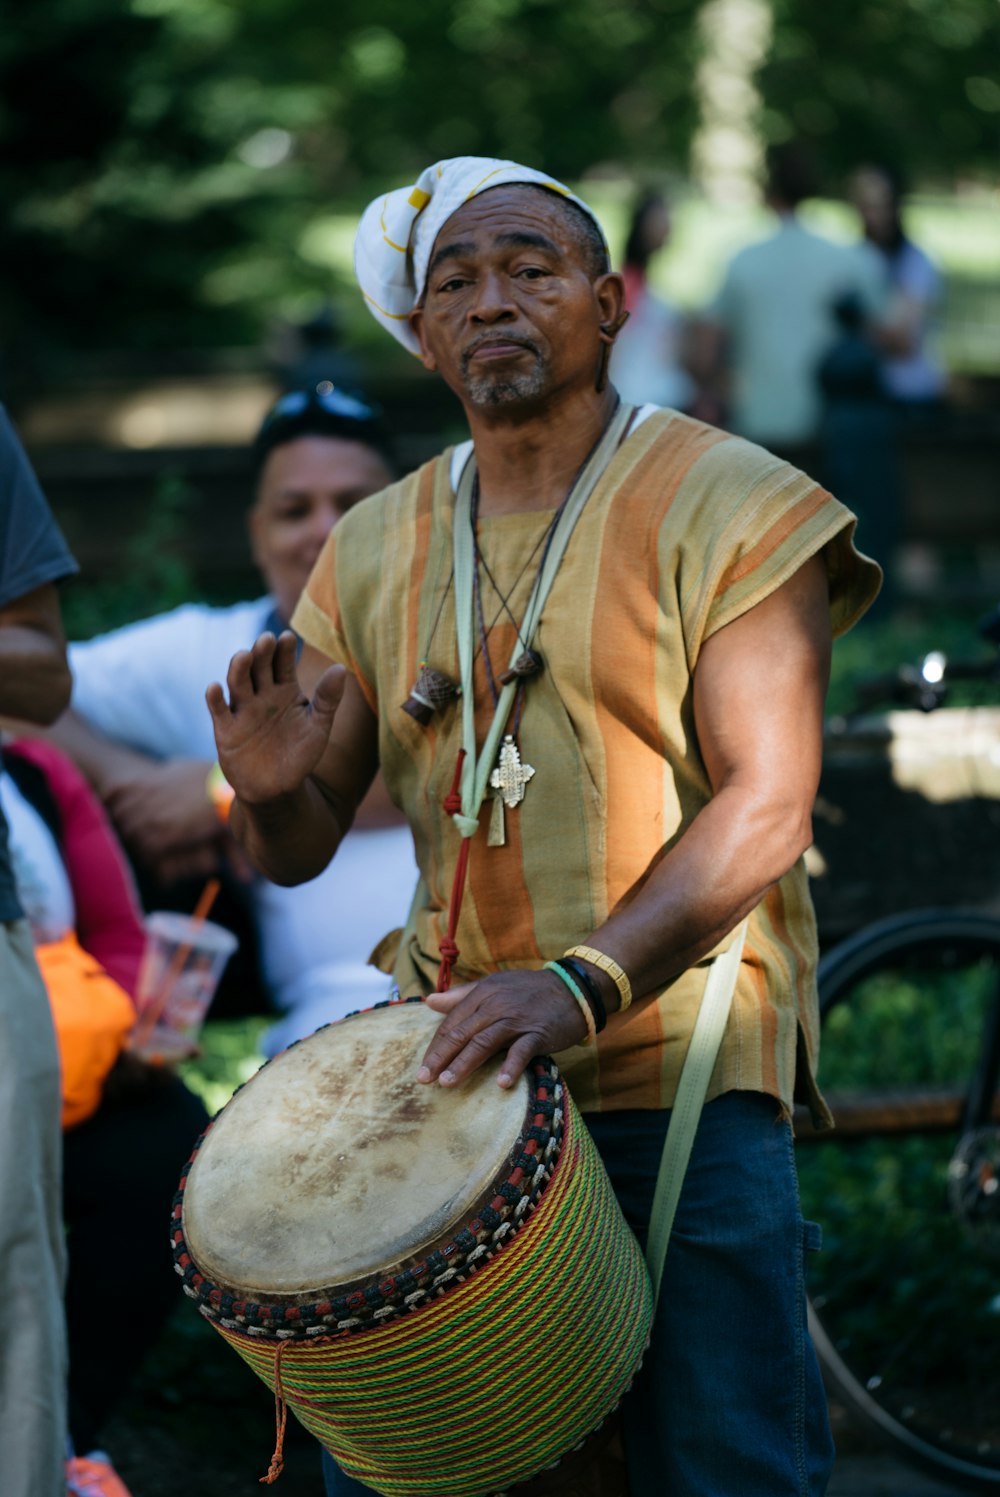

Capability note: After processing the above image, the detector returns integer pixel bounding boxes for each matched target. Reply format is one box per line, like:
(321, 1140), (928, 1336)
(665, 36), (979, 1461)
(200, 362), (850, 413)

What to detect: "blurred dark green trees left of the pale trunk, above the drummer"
(0, 0), (699, 389)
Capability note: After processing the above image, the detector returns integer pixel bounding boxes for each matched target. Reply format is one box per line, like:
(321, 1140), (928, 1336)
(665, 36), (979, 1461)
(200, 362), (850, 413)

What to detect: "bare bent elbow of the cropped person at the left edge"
(0, 582), (72, 725)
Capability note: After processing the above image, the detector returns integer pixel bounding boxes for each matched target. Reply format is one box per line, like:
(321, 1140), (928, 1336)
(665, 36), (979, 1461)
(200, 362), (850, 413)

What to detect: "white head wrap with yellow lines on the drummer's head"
(355, 156), (613, 355)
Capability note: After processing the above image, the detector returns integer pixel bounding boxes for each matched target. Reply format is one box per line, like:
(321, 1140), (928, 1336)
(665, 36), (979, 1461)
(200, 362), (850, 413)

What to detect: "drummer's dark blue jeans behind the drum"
(323, 1091), (834, 1497)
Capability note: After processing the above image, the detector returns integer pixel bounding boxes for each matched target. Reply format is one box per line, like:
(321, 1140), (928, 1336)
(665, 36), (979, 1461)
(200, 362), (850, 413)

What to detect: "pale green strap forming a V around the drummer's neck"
(452, 404), (635, 837)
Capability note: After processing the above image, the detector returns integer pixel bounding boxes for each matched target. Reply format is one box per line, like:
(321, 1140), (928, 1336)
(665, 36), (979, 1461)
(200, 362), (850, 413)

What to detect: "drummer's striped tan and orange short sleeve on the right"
(675, 437), (882, 669)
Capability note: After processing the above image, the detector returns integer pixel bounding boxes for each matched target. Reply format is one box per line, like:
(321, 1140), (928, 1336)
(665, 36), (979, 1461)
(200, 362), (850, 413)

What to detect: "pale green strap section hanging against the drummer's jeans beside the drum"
(645, 921), (747, 1304)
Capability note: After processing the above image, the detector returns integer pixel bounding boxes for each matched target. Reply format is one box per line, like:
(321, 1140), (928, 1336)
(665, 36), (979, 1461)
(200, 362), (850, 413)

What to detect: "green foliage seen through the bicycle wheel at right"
(798, 948), (1000, 1442)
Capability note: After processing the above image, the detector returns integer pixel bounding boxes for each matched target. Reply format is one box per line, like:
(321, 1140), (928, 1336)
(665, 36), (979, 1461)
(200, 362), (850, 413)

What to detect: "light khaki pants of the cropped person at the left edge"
(0, 921), (66, 1497)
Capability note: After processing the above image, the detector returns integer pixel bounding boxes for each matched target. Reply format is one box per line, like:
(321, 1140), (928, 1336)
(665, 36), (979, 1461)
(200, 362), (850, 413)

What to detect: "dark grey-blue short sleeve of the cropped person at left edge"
(0, 406), (78, 608)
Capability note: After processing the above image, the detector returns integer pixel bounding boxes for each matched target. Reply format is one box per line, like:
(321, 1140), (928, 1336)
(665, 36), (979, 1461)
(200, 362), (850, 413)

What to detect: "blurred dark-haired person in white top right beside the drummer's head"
(611, 192), (695, 410)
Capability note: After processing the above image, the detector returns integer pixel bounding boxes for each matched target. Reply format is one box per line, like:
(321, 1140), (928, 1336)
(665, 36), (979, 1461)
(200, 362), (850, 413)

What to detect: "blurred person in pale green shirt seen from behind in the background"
(696, 142), (879, 467)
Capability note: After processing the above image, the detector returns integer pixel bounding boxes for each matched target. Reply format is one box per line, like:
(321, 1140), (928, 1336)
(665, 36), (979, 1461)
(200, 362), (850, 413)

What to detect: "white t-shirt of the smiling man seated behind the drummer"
(69, 597), (418, 1054)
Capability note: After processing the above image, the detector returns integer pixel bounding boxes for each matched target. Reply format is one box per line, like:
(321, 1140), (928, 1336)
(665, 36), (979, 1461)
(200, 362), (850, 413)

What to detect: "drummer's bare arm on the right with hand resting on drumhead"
(421, 558), (831, 1084)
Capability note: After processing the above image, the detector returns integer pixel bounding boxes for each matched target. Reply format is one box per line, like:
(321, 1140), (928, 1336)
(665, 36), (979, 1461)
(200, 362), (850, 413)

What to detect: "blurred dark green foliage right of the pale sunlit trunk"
(757, 0), (1000, 184)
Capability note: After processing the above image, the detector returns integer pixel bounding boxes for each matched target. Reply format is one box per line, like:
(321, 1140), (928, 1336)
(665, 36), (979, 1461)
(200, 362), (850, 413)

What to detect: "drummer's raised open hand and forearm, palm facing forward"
(207, 633), (379, 885)
